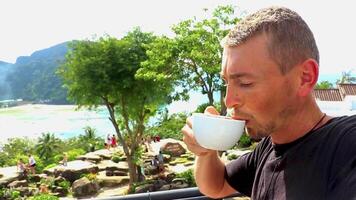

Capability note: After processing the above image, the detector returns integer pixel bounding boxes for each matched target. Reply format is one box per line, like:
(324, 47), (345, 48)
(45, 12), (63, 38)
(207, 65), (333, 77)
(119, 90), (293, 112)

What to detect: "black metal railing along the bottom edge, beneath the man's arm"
(96, 187), (243, 200)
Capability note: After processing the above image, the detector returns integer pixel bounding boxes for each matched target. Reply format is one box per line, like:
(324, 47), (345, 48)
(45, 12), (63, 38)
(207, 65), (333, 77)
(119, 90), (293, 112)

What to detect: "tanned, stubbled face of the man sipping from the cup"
(222, 35), (296, 139)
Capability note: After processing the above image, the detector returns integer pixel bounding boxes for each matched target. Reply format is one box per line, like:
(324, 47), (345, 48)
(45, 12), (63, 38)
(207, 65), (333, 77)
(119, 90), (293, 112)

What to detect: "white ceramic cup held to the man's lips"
(193, 113), (245, 151)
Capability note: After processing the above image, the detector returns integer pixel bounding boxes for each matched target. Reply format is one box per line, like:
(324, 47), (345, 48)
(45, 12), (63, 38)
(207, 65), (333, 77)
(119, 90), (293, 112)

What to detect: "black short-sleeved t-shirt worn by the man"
(225, 115), (356, 200)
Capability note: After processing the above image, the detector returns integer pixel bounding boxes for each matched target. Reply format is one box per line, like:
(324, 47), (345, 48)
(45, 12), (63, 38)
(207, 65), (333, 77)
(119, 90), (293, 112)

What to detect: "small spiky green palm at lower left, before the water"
(36, 133), (61, 164)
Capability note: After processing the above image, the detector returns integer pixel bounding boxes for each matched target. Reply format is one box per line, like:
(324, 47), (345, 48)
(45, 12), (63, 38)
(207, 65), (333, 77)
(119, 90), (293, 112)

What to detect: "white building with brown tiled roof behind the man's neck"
(313, 83), (356, 116)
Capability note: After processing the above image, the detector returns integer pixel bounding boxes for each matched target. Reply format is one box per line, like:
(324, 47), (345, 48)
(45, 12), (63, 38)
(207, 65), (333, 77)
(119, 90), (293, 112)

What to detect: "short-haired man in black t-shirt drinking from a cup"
(182, 7), (356, 199)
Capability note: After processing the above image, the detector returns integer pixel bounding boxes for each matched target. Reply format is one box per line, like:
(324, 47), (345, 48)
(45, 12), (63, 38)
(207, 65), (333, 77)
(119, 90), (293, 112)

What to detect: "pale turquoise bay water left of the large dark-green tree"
(0, 105), (115, 142)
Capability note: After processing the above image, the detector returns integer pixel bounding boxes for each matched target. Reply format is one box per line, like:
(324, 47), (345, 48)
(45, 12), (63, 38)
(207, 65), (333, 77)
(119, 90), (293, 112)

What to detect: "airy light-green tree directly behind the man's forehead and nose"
(144, 6), (238, 113)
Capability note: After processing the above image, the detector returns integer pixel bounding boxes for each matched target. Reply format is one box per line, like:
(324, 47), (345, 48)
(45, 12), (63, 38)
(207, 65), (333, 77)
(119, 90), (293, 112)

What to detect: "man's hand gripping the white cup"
(182, 106), (219, 156)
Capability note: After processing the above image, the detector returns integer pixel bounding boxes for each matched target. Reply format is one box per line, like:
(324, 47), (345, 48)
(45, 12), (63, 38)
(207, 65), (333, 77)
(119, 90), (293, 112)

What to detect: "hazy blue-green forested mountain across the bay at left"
(6, 42), (68, 104)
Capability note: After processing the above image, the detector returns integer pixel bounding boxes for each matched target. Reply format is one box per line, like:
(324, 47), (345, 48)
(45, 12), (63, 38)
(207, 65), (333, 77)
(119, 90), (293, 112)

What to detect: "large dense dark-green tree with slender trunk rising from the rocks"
(58, 28), (173, 185)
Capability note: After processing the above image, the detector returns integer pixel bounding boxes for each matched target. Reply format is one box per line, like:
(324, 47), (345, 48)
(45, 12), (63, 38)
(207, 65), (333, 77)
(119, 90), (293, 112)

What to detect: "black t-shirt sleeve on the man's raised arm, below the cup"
(225, 138), (268, 196)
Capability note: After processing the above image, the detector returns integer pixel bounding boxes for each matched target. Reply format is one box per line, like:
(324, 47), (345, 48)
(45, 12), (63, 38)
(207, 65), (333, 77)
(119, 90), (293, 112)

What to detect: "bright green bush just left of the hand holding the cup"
(146, 110), (188, 140)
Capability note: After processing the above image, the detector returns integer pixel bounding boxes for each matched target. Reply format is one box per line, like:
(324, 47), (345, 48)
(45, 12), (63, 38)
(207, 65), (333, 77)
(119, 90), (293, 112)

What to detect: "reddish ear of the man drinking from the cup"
(298, 59), (319, 97)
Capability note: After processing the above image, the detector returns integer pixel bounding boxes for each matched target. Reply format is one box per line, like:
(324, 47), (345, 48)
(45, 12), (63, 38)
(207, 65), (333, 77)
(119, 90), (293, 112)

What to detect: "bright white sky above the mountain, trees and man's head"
(0, 0), (356, 112)
